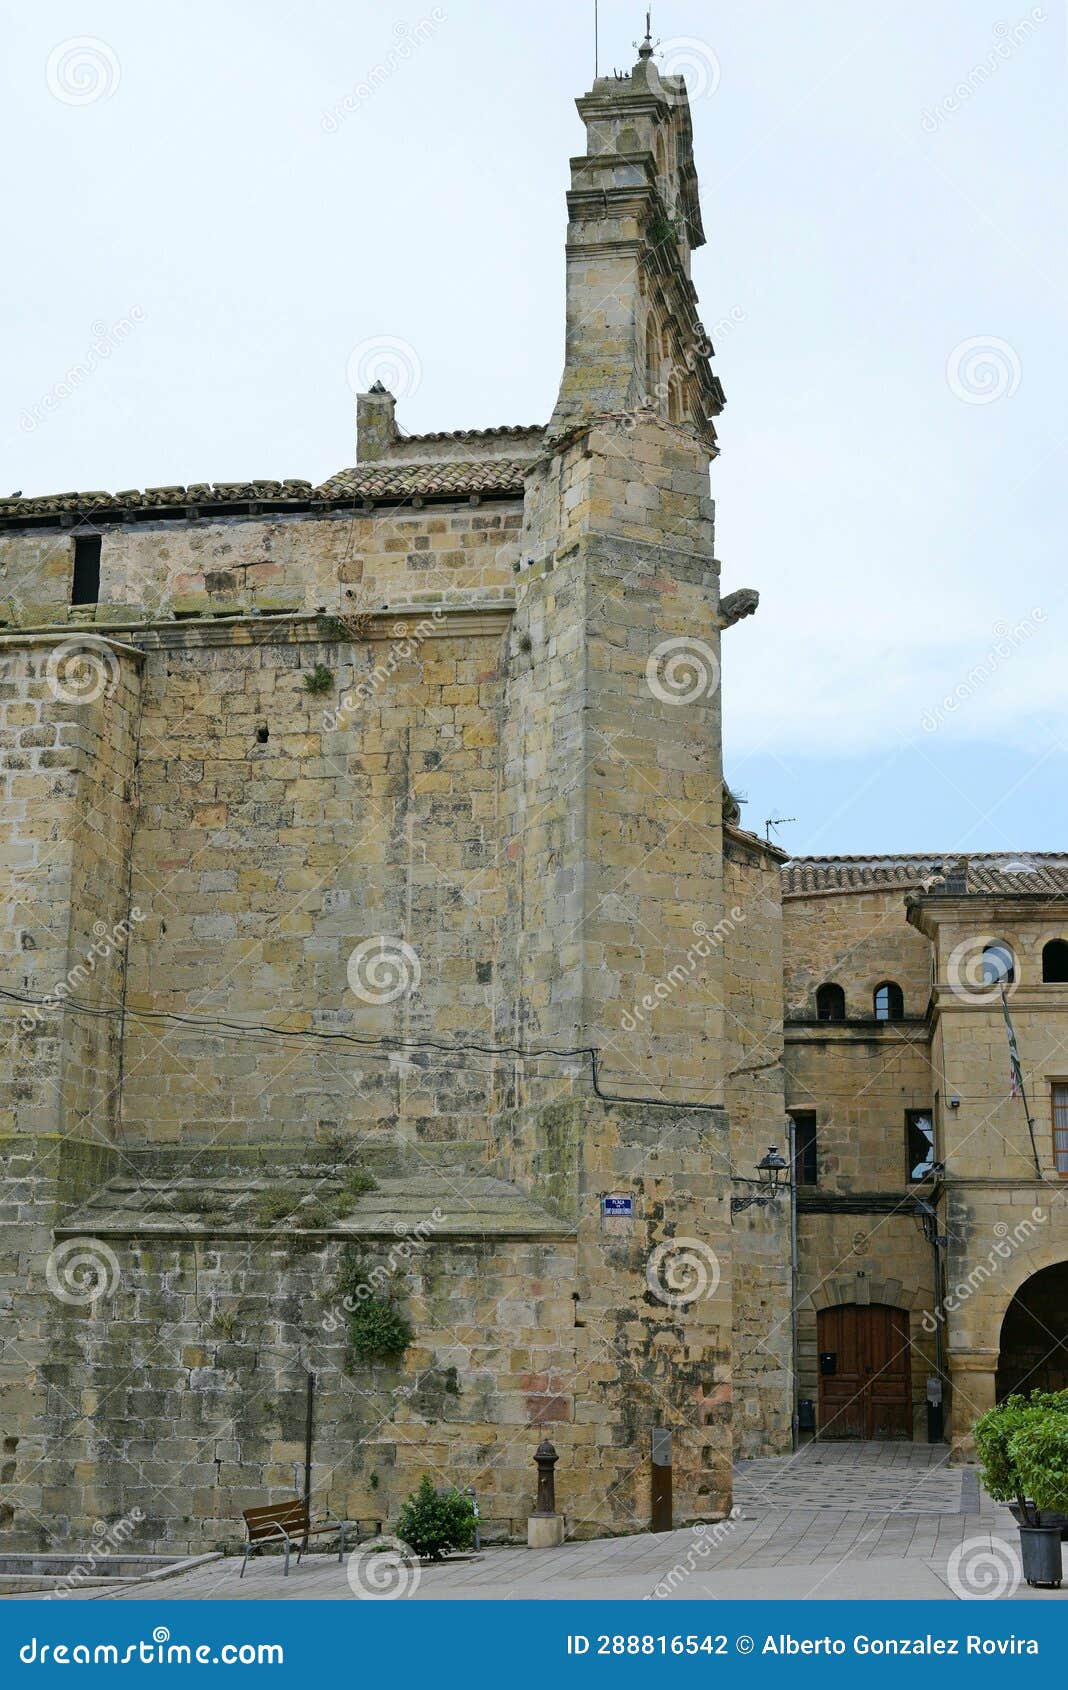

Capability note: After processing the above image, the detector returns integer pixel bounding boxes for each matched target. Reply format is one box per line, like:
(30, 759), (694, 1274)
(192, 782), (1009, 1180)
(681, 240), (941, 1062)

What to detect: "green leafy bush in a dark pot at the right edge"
(975, 1391), (1068, 1585)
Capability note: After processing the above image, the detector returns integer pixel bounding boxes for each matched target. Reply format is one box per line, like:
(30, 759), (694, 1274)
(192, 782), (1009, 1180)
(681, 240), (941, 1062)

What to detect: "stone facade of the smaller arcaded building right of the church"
(782, 855), (1068, 1457)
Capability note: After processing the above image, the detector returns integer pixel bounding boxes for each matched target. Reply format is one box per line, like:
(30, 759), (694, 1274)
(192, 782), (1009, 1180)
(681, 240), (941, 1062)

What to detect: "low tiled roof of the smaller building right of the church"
(782, 852), (1068, 897)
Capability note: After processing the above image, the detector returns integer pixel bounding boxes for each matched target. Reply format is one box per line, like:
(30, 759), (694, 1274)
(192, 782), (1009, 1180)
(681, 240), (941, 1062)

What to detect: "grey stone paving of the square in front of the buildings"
(6, 1443), (1068, 1602)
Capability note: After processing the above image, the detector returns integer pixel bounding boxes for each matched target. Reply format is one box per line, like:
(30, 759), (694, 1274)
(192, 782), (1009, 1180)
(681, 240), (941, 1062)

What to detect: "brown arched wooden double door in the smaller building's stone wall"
(818, 1303), (913, 1438)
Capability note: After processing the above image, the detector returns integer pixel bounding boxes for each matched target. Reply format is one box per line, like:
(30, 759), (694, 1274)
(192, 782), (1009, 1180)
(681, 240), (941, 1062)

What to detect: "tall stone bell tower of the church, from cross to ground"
(500, 41), (732, 1524)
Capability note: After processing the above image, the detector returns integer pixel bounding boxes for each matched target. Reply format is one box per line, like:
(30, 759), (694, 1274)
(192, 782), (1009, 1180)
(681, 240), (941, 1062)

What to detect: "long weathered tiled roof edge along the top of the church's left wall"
(0, 459), (527, 522)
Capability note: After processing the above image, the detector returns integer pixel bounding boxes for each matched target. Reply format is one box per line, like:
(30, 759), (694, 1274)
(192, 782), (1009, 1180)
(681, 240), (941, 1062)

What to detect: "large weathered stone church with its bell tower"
(0, 42), (750, 1548)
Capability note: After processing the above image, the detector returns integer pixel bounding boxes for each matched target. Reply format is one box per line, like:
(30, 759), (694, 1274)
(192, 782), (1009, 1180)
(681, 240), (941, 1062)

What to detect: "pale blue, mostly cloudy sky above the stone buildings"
(0, 0), (1068, 855)
